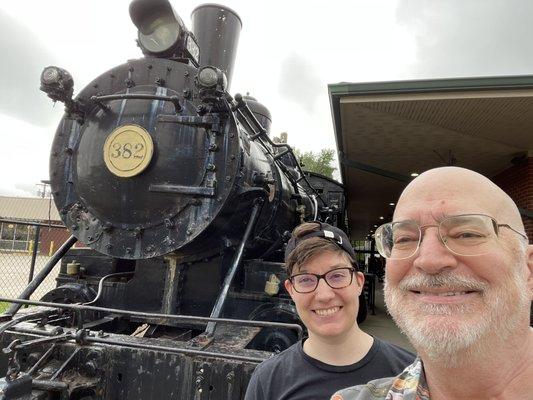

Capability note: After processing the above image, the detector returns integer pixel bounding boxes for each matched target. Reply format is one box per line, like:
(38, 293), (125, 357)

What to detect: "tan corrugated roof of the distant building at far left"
(0, 196), (61, 222)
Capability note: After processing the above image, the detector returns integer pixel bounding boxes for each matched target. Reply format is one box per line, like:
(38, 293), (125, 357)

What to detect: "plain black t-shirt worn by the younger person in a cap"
(244, 338), (415, 400)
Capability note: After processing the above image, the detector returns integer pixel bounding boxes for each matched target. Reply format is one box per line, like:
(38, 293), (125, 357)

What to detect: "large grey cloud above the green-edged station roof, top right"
(397, 0), (533, 78)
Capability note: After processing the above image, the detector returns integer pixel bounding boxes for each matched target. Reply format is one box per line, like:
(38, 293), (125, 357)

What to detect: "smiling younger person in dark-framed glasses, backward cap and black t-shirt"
(245, 222), (415, 400)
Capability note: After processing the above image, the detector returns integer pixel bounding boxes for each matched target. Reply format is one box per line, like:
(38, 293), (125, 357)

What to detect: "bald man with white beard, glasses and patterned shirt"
(332, 167), (533, 400)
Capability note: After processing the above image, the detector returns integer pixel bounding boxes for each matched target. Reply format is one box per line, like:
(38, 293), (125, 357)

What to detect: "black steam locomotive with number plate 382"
(0, 0), (354, 399)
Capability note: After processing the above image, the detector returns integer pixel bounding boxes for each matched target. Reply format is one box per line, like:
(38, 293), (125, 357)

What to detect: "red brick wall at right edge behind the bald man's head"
(492, 157), (533, 243)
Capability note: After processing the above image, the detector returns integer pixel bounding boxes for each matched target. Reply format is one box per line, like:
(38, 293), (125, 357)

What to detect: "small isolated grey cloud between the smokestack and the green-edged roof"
(279, 52), (325, 114)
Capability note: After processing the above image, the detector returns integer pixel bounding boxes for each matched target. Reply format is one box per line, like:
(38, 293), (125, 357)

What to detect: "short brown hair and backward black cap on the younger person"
(285, 221), (358, 276)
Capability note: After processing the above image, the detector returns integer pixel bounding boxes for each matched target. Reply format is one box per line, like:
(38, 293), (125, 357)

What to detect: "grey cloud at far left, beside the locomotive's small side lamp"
(0, 10), (58, 126)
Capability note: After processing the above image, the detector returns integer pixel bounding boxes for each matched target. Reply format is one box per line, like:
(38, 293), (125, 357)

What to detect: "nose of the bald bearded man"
(413, 227), (457, 274)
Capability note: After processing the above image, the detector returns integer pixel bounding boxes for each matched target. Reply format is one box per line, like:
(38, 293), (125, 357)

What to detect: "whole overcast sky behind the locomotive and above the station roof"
(0, 0), (533, 196)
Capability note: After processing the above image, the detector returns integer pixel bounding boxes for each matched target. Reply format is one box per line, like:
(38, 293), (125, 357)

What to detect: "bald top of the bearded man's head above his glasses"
(394, 167), (524, 232)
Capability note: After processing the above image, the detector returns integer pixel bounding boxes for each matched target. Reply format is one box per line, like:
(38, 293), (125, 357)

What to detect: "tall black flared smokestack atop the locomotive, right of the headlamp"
(191, 4), (242, 90)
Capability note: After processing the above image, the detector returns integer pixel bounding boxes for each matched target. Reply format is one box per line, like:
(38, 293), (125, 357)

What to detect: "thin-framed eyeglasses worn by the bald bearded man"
(374, 214), (527, 260)
